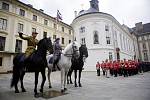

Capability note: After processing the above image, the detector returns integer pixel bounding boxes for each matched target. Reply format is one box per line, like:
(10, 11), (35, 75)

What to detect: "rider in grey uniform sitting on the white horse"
(52, 38), (62, 71)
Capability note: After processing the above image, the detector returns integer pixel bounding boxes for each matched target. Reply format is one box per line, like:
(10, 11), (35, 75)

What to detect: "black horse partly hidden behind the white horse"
(67, 44), (88, 87)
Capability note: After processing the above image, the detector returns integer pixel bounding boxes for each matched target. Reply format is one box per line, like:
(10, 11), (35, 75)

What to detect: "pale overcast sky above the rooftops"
(20, 0), (150, 28)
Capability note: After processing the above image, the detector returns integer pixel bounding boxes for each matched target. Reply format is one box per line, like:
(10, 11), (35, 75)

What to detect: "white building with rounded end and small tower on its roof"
(71, 0), (138, 71)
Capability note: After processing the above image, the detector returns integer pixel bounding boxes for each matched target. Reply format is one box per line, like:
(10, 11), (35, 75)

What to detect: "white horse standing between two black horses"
(47, 41), (79, 92)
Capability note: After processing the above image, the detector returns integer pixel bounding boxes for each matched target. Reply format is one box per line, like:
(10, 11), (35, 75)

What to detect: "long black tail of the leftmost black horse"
(10, 55), (21, 88)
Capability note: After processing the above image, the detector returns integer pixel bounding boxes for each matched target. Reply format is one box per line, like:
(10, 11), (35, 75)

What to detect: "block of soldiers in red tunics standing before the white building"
(96, 59), (140, 78)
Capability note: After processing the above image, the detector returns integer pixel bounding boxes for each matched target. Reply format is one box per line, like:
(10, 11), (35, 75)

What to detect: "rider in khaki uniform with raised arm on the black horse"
(18, 32), (38, 59)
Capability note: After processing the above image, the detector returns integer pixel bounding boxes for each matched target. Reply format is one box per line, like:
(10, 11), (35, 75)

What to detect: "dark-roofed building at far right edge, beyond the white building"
(132, 22), (150, 62)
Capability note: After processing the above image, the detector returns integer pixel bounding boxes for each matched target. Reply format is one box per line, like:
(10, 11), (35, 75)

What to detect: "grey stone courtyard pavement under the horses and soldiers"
(0, 72), (150, 100)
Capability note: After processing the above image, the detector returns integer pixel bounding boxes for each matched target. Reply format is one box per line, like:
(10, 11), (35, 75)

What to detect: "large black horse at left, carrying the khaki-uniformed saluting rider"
(11, 37), (52, 97)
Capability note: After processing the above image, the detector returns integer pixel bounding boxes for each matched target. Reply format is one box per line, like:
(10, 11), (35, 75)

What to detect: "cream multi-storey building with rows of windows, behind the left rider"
(0, 0), (73, 72)
